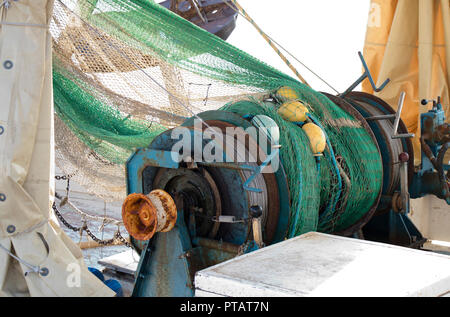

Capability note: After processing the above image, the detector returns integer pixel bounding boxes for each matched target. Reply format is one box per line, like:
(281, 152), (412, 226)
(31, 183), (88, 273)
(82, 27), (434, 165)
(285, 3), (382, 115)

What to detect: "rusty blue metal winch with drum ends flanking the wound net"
(124, 68), (450, 296)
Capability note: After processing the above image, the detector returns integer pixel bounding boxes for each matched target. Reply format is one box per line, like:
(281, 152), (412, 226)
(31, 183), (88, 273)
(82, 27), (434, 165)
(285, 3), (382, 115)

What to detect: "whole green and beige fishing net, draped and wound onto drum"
(50, 0), (381, 236)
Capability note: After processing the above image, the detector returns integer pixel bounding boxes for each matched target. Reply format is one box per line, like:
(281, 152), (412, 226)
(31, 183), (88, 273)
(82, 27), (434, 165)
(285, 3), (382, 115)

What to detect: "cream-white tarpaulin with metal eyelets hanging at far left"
(0, 0), (114, 296)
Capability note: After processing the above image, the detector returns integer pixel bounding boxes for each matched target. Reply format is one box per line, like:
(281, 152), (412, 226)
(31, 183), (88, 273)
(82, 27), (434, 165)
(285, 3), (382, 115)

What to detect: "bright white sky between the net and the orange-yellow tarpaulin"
(228, 0), (370, 94)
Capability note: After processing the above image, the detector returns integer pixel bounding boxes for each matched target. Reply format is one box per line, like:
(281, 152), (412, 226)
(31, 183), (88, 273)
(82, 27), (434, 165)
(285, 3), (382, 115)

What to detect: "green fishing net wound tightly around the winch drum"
(222, 95), (382, 237)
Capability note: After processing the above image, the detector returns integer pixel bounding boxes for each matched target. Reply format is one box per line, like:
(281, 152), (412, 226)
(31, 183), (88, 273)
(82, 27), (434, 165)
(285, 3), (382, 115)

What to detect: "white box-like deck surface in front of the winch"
(195, 233), (450, 297)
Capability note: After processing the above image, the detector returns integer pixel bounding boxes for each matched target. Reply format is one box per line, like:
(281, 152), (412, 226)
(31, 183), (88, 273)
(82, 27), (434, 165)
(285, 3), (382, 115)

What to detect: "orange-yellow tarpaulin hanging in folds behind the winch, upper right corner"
(362, 0), (450, 164)
